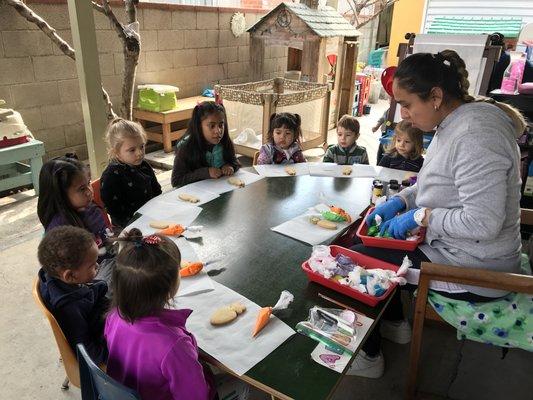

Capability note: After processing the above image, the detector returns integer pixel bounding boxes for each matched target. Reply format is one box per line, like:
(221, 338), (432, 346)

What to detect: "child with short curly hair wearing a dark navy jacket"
(37, 226), (109, 364)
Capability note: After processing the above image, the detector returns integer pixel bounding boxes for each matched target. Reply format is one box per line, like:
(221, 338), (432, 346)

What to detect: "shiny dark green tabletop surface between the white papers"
(181, 176), (390, 400)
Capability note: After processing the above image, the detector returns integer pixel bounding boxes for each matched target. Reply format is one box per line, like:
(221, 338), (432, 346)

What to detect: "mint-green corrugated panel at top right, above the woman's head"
(427, 17), (522, 38)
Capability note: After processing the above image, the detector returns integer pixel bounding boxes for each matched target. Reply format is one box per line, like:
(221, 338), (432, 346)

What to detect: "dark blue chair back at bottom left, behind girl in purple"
(76, 344), (141, 400)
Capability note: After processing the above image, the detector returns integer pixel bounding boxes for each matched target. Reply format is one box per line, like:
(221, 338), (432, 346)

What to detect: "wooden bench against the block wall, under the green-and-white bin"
(133, 96), (215, 153)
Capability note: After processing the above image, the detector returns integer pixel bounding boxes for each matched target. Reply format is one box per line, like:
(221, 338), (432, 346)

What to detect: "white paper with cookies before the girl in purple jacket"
(171, 282), (295, 375)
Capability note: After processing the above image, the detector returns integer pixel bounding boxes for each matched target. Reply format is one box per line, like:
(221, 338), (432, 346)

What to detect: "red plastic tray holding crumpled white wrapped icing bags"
(302, 245), (399, 307)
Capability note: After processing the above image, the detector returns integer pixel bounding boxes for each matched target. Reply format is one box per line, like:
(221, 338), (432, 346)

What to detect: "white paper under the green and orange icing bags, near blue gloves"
(271, 205), (355, 246)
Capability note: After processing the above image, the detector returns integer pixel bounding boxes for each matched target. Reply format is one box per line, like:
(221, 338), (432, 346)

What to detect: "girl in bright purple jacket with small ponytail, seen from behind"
(104, 229), (216, 400)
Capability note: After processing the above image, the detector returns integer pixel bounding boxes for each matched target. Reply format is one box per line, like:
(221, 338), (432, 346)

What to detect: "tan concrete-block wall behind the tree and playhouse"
(0, 2), (287, 159)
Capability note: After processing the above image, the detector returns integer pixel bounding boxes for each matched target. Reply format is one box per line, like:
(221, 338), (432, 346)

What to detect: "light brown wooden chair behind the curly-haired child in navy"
(32, 278), (80, 390)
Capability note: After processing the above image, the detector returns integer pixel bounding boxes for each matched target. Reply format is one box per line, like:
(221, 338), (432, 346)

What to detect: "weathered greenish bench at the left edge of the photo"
(0, 139), (44, 196)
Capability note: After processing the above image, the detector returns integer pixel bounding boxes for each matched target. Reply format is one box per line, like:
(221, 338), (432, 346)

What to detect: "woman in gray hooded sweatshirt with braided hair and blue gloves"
(351, 50), (525, 377)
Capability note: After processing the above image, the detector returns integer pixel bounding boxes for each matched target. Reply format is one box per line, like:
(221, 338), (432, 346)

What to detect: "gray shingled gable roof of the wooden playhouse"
(248, 3), (361, 37)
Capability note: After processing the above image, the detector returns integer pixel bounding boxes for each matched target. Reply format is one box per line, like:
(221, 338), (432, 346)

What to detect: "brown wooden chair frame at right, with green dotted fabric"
(406, 209), (533, 399)
